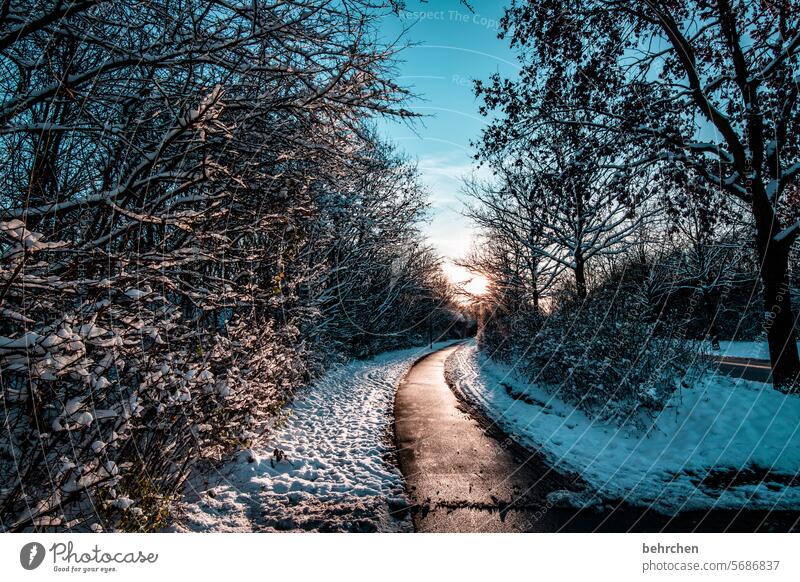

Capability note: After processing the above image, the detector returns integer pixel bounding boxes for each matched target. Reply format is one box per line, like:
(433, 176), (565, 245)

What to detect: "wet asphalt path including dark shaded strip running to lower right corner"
(395, 346), (800, 532)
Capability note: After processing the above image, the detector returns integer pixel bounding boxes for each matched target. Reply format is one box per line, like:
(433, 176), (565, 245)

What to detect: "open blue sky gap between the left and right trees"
(378, 0), (519, 291)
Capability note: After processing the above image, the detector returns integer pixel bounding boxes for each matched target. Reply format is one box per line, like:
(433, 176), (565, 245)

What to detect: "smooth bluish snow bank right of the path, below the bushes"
(446, 345), (800, 513)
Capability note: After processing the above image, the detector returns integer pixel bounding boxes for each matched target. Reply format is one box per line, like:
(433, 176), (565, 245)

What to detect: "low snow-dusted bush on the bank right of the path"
(481, 290), (702, 424)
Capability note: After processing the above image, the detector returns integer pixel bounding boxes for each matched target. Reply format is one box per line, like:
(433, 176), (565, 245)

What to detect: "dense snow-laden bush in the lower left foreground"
(0, 243), (318, 530)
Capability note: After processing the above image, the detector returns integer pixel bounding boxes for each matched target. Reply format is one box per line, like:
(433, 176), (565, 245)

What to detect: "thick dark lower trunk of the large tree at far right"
(759, 229), (800, 390)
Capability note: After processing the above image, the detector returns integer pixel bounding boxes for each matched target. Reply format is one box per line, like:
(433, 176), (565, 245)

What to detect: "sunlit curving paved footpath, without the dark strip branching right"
(395, 346), (572, 532)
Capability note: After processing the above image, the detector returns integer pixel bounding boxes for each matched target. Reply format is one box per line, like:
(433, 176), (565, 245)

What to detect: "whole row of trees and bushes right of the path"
(465, 0), (800, 419)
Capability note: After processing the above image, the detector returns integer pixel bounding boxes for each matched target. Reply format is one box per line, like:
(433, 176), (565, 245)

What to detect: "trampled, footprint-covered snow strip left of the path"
(174, 343), (454, 532)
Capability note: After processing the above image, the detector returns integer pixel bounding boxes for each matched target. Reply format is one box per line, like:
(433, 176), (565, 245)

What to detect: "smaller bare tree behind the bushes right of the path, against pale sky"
(471, 128), (658, 299)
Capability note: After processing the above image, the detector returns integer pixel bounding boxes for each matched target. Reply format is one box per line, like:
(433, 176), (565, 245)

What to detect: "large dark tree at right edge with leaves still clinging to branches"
(478, 0), (800, 387)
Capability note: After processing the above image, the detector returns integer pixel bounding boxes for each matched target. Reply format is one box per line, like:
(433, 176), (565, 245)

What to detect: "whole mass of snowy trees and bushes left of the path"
(0, 0), (460, 531)
